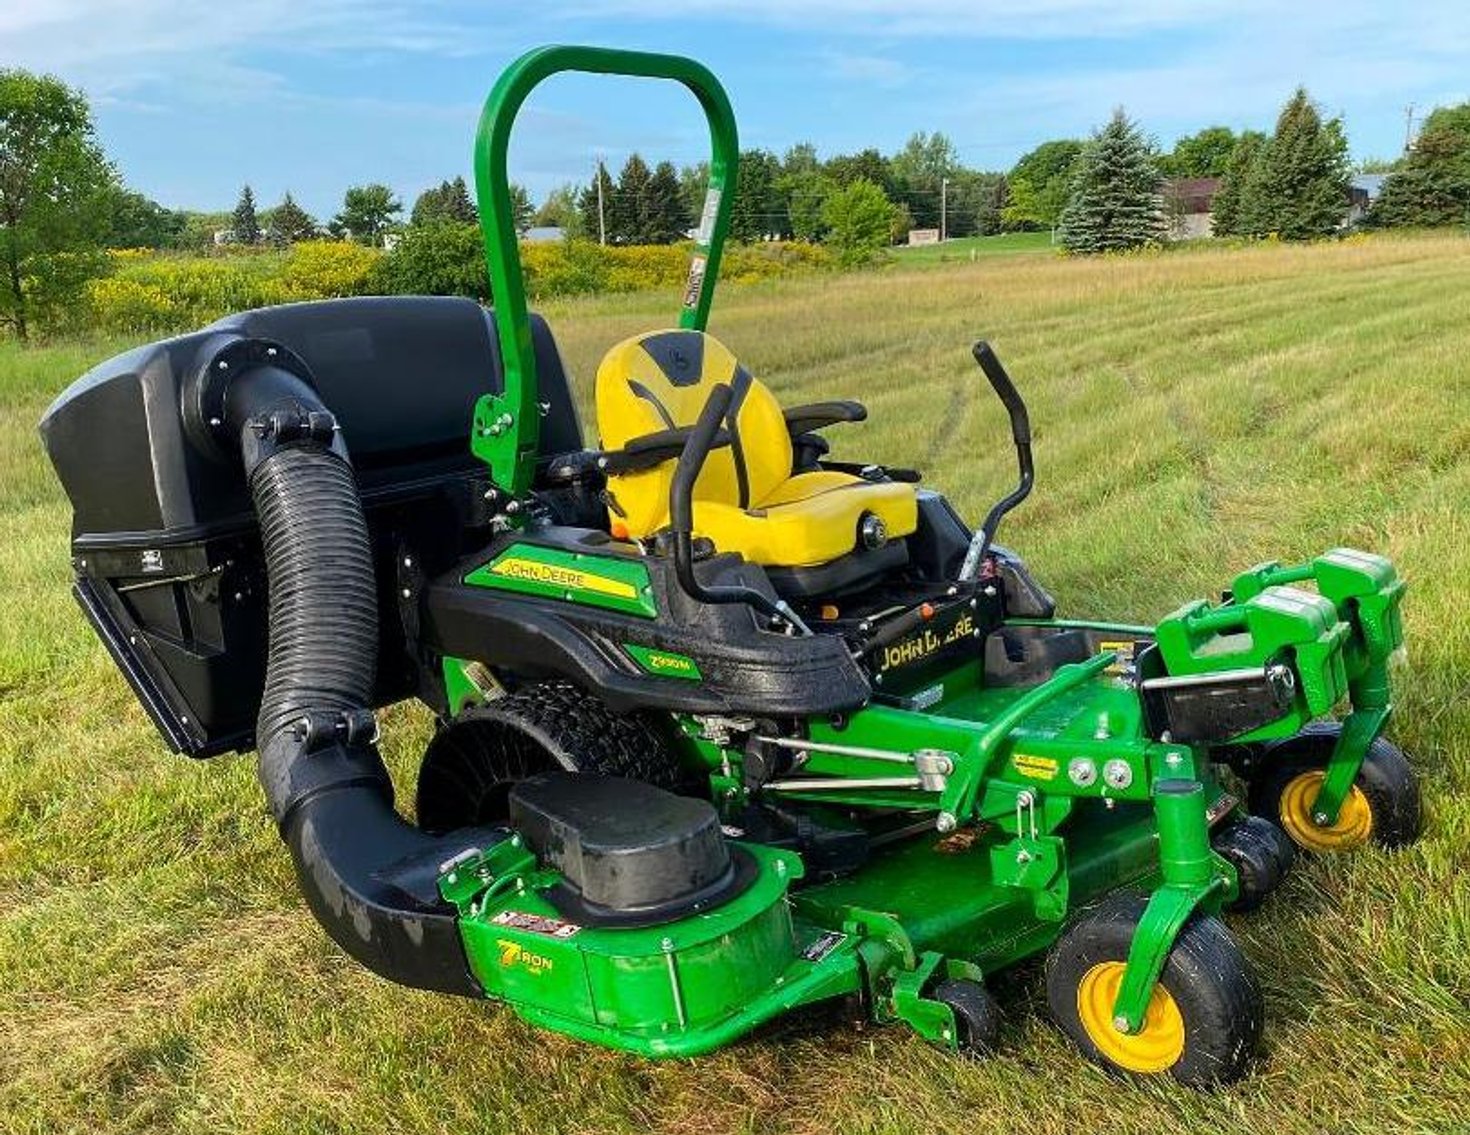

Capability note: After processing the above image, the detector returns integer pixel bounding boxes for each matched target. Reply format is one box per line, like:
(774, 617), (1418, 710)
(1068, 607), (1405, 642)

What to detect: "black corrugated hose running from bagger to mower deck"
(228, 352), (482, 997)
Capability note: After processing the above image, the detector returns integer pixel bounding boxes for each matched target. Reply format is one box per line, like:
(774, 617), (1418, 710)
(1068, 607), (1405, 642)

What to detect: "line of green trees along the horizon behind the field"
(0, 69), (1470, 337)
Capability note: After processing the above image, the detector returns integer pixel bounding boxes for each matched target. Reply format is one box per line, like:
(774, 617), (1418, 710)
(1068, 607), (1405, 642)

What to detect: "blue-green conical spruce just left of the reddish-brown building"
(1060, 107), (1164, 253)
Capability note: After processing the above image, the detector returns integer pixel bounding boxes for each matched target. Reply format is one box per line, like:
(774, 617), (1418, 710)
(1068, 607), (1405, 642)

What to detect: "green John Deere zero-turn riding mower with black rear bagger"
(41, 47), (1419, 1084)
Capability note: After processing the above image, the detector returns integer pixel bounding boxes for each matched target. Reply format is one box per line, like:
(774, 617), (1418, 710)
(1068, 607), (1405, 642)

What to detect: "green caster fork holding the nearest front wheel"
(1113, 779), (1232, 1034)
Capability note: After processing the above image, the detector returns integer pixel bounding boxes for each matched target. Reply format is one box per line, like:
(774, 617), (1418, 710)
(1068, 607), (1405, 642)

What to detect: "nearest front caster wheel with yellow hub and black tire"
(1047, 895), (1264, 1086)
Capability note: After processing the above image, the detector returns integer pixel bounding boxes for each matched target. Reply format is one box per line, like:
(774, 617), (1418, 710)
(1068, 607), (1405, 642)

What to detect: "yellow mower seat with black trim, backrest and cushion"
(597, 331), (919, 568)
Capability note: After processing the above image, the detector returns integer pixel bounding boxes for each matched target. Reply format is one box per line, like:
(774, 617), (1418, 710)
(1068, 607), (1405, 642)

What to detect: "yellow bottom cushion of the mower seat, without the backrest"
(694, 472), (919, 568)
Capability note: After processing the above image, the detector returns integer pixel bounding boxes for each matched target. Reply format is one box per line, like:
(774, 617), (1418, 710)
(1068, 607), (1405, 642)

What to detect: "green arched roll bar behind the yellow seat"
(470, 46), (739, 497)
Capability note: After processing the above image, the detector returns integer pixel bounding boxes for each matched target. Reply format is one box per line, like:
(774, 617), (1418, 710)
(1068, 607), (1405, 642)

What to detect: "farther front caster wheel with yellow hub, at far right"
(1251, 722), (1423, 854)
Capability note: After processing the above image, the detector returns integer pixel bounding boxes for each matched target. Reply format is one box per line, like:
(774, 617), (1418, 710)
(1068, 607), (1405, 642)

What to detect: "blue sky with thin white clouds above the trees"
(0, 0), (1470, 218)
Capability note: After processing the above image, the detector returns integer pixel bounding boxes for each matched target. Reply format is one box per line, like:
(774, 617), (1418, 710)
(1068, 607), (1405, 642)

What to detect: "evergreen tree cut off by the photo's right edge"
(1369, 103), (1470, 226)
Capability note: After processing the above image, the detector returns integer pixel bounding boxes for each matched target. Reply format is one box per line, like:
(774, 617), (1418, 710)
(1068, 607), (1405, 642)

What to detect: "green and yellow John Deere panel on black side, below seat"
(465, 544), (659, 619)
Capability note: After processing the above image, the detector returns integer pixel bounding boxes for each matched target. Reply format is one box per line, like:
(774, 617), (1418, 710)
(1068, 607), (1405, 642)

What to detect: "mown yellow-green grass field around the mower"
(0, 237), (1470, 1135)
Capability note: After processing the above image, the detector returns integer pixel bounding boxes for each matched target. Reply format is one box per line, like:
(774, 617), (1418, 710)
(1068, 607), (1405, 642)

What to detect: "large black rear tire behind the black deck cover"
(417, 679), (686, 834)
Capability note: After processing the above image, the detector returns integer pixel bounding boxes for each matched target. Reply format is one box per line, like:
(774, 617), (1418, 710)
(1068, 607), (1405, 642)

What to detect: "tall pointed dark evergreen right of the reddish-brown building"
(1239, 87), (1351, 240)
